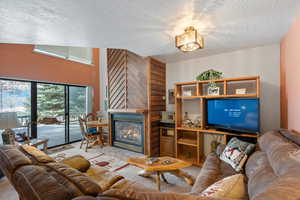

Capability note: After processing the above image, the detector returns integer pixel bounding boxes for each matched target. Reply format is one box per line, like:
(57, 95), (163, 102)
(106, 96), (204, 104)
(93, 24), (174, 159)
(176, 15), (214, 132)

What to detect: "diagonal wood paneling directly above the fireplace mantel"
(107, 49), (148, 109)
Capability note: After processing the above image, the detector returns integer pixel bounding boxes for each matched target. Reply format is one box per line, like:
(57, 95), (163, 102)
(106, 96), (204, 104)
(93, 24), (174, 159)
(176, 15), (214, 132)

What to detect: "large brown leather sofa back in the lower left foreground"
(0, 146), (101, 200)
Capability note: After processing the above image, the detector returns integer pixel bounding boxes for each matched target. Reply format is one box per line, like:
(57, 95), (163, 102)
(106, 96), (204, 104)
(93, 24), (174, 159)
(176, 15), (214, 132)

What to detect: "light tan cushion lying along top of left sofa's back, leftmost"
(20, 145), (55, 163)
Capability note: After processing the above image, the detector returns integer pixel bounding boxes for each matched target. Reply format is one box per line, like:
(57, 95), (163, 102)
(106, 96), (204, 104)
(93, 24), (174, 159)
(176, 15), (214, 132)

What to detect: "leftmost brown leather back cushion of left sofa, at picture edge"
(0, 145), (32, 179)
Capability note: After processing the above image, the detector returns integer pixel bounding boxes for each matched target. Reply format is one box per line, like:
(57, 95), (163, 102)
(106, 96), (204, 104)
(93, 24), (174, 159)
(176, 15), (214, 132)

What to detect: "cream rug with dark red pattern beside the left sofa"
(88, 153), (129, 172)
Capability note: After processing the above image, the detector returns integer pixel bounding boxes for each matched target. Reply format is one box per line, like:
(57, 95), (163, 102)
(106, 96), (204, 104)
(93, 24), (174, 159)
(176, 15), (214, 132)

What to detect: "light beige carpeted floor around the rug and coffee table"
(0, 143), (200, 200)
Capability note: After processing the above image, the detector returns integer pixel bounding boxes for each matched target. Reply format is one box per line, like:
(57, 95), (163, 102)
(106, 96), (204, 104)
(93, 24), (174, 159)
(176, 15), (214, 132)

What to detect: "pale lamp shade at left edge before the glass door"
(0, 112), (21, 129)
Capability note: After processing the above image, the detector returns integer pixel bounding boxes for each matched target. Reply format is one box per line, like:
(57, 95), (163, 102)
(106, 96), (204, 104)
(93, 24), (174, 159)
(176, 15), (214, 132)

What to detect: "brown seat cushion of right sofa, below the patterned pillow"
(191, 153), (237, 194)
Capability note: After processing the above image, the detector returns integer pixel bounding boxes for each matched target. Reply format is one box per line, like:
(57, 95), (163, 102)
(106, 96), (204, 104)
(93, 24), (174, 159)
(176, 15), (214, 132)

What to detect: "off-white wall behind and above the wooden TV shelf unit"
(167, 44), (280, 155)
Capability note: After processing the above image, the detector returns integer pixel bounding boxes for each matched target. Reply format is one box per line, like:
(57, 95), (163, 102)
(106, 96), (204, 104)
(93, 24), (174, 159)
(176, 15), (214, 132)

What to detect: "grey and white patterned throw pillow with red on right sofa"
(220, 137), (255, 172)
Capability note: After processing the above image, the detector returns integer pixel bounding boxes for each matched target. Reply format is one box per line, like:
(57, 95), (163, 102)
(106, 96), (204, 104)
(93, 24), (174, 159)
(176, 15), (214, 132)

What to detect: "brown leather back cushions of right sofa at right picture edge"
(246, 131), (300, 200)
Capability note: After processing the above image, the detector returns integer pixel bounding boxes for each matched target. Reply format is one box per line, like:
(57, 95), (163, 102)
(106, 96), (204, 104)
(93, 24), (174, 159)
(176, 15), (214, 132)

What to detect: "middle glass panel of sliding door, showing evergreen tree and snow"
(37, 83), (67, 147)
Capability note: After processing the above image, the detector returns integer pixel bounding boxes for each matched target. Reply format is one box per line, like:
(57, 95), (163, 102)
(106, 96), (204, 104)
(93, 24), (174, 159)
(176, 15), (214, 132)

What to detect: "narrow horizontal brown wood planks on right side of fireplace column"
(147, 58), (166, 156)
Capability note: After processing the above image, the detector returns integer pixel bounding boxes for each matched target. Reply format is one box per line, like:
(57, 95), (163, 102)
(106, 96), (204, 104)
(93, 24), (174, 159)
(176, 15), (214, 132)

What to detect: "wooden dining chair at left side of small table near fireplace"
(78, 117), (102, 152)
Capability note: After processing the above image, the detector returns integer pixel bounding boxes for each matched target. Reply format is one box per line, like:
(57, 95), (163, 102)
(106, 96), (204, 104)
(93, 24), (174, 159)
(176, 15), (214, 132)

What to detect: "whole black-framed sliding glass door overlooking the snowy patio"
(0, 79), (92, 147)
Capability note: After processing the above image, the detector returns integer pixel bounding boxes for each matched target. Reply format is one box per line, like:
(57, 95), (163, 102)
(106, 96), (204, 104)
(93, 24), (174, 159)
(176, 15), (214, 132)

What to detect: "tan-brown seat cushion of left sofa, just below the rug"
(85, 167), (124, 191)
